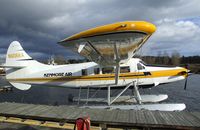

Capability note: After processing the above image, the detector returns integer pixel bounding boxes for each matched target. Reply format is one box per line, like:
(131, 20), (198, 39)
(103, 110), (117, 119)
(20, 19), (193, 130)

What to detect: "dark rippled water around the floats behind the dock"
(0, 75), (200, 111)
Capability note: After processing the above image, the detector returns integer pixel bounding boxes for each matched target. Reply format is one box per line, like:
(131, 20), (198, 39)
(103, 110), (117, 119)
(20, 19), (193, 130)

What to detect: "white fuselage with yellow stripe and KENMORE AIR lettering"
(6, 58), (186, 88)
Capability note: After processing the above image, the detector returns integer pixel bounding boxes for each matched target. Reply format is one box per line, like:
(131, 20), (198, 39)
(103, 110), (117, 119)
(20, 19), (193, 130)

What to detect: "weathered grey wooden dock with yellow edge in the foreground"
(0, 102), (200, 129)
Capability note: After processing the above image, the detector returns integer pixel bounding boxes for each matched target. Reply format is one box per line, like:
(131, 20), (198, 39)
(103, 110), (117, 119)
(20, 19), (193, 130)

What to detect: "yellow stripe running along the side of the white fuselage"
(8, 68), (186, 82)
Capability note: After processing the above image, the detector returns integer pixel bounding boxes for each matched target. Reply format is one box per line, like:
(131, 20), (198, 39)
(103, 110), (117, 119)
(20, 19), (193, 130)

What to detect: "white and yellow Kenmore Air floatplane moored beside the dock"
(3, 21), (188, 111)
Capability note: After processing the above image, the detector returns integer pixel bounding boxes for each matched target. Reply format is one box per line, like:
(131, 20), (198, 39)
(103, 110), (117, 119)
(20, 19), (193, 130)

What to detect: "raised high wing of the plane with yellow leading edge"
(59, 21), (156, 66)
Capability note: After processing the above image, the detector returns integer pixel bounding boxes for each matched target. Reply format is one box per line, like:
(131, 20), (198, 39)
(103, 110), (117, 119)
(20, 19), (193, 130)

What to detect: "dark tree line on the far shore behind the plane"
(43, 51), (200, 73)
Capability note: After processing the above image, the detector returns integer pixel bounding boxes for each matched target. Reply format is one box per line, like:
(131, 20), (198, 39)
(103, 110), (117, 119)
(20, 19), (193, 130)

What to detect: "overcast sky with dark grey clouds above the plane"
(0, 0), (200, 59)
